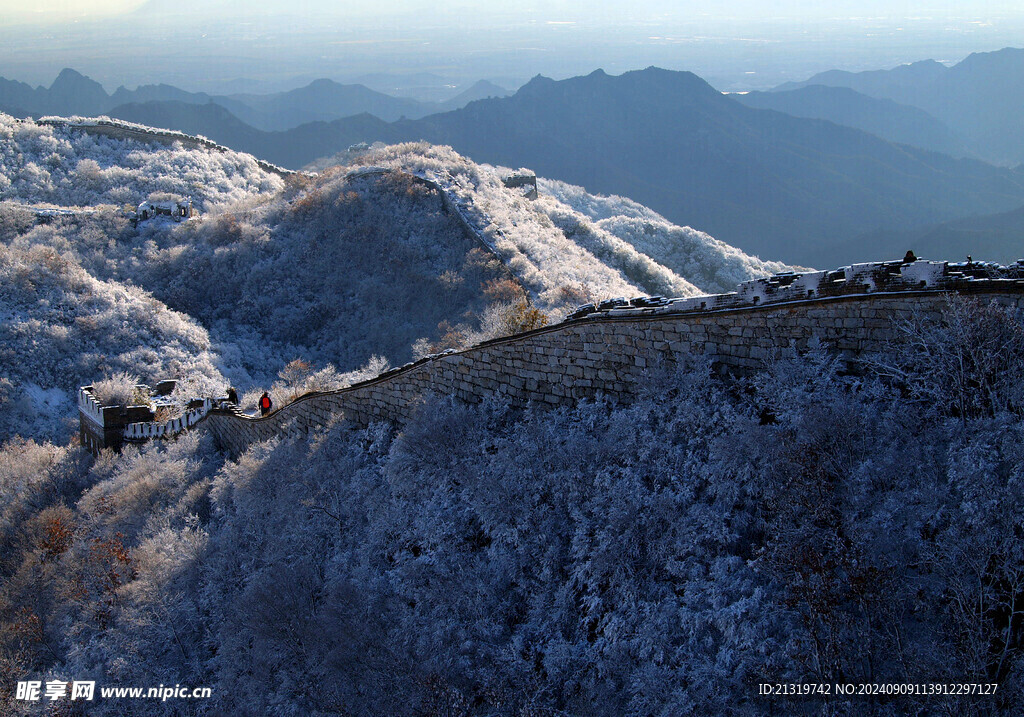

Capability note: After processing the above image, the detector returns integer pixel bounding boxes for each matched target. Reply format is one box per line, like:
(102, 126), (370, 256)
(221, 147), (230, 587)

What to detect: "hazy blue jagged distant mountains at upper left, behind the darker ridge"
(0, 69), (508, 131)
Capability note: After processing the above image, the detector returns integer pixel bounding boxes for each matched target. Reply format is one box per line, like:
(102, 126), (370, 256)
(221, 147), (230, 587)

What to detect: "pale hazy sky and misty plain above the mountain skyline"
(0, 0), (1024, 92)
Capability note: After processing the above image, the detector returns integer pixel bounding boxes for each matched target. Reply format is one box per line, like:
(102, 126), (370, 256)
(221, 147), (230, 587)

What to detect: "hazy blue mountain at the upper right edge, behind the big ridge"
(776, 47), (1024, 165)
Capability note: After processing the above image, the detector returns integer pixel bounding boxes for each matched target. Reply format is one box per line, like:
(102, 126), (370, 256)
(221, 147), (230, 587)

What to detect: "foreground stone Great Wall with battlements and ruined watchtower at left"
(79, 261), (1024, 456)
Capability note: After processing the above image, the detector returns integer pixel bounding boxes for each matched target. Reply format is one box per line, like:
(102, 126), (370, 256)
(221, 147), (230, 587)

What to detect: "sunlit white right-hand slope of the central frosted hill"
(362, 143), (790, 301)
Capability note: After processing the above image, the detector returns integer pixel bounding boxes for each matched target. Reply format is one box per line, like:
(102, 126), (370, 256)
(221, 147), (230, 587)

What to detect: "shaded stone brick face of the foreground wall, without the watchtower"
(195, 262), (1024, 455)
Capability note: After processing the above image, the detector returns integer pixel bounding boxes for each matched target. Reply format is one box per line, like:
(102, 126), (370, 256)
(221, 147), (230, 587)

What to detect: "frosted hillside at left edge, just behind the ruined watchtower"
(0, 232), (225, 437)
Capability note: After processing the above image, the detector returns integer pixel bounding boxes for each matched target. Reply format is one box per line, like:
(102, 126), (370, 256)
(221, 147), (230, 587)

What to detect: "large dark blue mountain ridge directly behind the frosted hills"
(81, 69), (1024, 264)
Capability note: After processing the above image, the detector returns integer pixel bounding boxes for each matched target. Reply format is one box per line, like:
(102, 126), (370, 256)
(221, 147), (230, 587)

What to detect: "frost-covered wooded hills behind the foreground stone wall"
(0, 116), (782, 439)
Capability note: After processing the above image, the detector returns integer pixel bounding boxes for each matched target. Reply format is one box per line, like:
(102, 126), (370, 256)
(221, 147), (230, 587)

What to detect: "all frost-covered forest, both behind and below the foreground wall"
(0, 116), (1024, 717)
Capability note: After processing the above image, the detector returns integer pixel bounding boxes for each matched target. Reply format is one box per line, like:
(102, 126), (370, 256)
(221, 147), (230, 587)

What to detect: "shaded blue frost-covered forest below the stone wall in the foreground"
(0, 302), (1024, 715)
